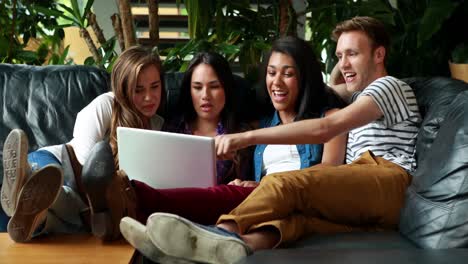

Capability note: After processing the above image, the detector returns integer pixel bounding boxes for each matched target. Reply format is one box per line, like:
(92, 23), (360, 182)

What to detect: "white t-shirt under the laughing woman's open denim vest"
(262, 145), (301, 175)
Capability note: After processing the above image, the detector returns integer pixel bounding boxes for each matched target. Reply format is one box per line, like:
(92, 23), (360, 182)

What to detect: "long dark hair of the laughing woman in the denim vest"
(261, 36), (345, 121)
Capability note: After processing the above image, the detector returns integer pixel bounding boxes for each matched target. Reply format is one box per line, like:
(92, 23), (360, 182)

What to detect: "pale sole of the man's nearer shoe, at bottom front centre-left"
(146, 213), (248, 264)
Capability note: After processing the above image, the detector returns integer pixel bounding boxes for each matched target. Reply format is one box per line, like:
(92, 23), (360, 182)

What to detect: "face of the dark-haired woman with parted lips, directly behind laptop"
(190, 63), (226, 122)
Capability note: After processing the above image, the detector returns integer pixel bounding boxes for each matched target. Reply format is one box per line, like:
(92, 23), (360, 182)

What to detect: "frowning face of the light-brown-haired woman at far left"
(132, 64), (161, 118)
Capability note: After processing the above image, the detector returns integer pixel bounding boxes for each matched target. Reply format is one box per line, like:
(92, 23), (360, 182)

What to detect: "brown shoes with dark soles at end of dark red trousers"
(81, 141), (136, 240)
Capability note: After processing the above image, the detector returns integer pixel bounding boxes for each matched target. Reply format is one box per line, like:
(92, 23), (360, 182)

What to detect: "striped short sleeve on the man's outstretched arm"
(361, 76), (411, 127)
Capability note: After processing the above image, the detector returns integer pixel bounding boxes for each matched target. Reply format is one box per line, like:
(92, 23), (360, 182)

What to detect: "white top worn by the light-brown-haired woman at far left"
(41, 92), (164, 164)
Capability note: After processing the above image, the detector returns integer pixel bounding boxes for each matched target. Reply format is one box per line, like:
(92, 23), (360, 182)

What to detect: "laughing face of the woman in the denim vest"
(266, 52), (299, 123)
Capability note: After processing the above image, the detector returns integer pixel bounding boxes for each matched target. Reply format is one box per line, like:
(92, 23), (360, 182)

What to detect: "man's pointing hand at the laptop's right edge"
(215, 132), (249, 160)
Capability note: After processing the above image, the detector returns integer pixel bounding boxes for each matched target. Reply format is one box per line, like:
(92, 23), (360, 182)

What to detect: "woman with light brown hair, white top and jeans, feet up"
(1, 44), (165, 242)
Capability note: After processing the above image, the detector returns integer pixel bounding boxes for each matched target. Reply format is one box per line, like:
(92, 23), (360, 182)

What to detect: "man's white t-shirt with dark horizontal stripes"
(346, 76), (422, 172)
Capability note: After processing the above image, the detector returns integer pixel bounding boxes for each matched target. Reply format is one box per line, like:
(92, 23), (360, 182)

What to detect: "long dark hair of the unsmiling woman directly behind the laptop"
(179, 52), (239, 133)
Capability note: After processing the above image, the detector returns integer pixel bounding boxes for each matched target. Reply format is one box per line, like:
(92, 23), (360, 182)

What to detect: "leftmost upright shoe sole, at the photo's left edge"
(1, 129), (28, 217)
